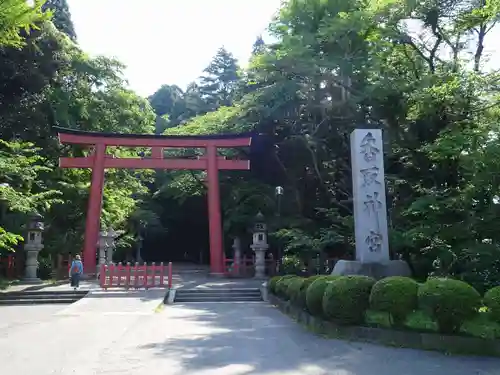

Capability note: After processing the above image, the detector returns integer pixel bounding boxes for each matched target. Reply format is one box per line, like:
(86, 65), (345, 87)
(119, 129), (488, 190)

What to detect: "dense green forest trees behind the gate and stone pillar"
(0, 0), (500, 289)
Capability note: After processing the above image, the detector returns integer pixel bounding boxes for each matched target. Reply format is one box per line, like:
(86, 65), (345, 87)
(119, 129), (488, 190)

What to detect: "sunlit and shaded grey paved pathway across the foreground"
(0, 290), (500, 375)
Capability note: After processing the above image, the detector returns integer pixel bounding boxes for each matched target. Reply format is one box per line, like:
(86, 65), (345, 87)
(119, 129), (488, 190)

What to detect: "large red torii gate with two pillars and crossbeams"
(55, 127), (252, 274)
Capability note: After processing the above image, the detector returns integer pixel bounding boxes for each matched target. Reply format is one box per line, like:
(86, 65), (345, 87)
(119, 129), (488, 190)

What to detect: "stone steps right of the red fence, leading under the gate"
(174, 288), (262, 303)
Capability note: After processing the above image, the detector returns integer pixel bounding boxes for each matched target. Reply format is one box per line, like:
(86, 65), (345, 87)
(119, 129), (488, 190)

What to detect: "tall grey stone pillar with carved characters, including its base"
(332, 129), (411, 278)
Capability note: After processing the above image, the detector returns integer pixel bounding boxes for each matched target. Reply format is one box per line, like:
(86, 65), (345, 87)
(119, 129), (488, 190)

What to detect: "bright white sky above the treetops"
(68, 0), (500, 96)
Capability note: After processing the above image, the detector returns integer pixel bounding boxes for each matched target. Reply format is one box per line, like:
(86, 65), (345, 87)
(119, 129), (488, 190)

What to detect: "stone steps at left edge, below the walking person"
(0, 290), (88, 306)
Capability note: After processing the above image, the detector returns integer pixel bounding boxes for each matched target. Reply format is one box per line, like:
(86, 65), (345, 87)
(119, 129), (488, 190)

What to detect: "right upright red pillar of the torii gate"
(206, 145), (223, 274)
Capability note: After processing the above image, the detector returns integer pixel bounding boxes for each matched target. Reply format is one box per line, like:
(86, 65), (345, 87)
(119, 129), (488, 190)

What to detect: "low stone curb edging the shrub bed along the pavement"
(268, 294), (500, 357)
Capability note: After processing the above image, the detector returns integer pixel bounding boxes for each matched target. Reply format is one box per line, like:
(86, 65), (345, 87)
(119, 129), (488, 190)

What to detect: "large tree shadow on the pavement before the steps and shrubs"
(139, 303), (500, 375)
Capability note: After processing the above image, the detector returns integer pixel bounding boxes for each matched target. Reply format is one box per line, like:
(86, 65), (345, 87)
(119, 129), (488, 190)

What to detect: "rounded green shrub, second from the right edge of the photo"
(418, 278), (481, 333)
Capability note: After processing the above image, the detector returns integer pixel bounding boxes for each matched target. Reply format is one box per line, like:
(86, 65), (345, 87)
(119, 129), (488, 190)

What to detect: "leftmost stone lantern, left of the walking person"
(23, 214), (44, 283)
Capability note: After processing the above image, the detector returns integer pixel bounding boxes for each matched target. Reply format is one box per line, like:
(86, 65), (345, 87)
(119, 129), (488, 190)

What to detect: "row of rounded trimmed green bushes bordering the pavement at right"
(268, 275), (500, 337)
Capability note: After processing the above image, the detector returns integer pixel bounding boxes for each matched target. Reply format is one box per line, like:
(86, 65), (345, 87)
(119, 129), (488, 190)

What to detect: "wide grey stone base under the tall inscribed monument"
(332, 260), (411, 279)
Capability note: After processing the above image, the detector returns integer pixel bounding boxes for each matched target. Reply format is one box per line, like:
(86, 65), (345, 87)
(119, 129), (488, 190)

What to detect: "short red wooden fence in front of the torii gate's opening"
(99, 262), (172, 289)
